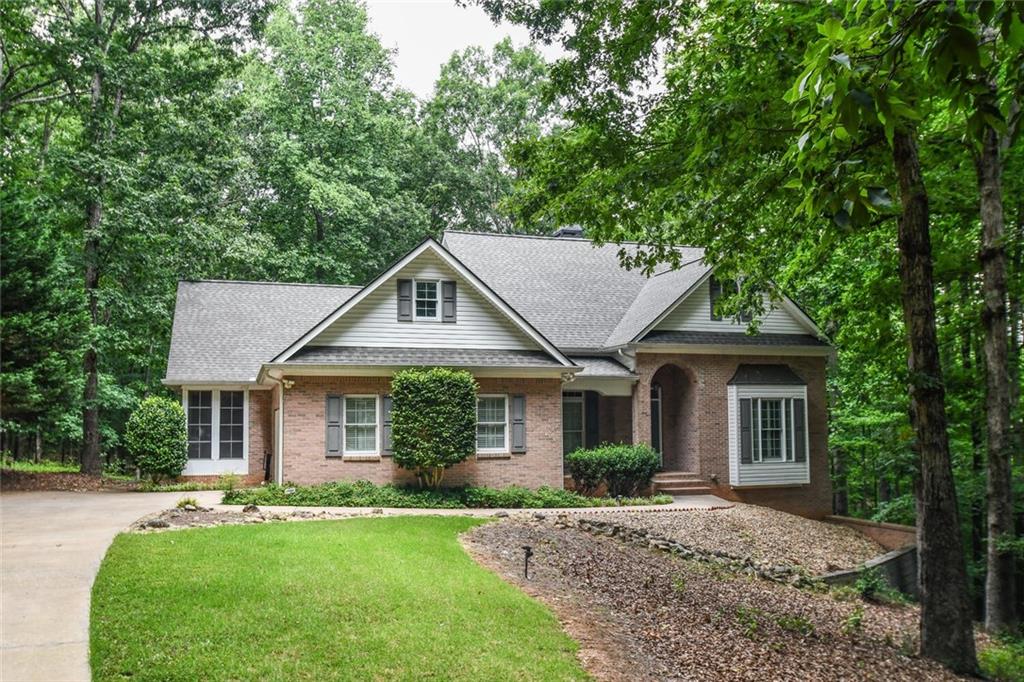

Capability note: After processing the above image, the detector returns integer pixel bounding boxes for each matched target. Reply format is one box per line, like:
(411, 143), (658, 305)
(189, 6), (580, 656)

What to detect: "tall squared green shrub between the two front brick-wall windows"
(391, 368), (476, 488)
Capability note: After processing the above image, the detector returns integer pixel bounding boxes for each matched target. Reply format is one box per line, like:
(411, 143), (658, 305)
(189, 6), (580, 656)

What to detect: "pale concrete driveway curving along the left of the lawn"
(0, 492), (221, 682)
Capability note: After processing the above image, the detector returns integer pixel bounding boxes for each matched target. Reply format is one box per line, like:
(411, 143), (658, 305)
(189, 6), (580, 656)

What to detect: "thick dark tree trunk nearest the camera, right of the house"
(893, 130), (978, 673)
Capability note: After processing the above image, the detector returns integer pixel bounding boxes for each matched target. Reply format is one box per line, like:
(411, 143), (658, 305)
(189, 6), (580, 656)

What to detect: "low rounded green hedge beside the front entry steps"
(565, 443), (660, 496)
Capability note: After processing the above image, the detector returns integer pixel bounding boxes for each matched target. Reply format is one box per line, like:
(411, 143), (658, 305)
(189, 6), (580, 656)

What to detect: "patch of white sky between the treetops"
(367, 0), (562, 99)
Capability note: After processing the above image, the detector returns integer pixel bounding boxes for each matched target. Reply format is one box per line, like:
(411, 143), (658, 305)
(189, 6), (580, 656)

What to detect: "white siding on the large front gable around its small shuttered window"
(309, 251), (539, 350)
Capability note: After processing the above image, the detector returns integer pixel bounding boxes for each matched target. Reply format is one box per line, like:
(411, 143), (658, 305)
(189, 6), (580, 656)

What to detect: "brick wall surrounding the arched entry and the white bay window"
(633, 353), (831, 518)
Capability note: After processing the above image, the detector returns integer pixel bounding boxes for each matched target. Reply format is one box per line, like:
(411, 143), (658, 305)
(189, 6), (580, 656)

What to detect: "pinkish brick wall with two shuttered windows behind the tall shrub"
(284, 377), (562, 487)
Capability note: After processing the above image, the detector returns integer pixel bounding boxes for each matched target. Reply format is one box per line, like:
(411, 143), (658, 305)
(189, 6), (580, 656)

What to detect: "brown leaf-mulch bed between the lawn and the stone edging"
(464, 518), (957, 682)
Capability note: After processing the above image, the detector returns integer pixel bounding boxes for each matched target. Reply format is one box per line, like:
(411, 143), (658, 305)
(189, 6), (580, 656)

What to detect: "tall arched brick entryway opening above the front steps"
(650, 365), (698, 471)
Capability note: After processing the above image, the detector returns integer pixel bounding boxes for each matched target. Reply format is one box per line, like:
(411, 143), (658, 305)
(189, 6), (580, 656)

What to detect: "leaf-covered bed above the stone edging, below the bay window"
(579, 504), (886, 574)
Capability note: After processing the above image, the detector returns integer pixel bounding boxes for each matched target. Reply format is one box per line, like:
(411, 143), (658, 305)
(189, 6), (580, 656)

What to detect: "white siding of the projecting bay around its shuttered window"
(728, 386), (811, 486)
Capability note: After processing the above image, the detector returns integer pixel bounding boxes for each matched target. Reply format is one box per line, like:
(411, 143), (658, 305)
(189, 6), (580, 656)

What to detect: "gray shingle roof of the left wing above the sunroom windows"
(165, 281), (359, 384)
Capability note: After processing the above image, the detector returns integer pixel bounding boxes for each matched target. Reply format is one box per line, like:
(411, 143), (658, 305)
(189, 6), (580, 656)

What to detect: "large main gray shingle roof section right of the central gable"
(443, 231), (708, 349)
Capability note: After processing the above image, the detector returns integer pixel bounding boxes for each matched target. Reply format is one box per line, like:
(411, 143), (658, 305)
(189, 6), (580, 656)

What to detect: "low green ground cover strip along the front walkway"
(223, 480), (672, 509)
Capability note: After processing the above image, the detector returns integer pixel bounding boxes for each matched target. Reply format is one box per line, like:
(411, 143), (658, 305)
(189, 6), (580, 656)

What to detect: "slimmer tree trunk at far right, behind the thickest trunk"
(976, 122), (1017, 632)
